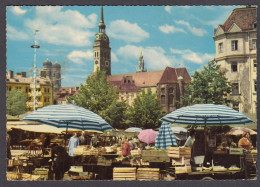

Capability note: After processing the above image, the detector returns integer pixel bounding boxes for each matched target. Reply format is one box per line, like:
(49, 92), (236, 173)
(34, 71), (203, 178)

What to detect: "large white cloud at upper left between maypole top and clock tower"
(21, 6), (97, 46)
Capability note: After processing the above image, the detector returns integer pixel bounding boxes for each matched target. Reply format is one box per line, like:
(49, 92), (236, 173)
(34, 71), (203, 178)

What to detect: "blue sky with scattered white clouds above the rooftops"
(6, 6), (241, 87)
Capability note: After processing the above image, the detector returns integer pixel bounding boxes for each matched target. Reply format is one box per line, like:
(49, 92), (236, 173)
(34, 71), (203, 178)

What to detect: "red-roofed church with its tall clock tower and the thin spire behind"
(93, 7), (191, 113)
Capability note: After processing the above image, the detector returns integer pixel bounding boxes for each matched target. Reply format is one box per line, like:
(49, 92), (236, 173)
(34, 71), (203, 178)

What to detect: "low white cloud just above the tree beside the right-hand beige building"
(170, 48), (214, 64)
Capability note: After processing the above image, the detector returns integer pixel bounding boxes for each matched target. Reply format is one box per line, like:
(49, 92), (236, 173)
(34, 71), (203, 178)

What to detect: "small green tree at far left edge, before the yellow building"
(6, 90), (26, 116)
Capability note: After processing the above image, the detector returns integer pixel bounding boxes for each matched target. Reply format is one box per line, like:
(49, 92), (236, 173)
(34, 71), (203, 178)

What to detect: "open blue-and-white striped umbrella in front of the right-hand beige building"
(161, 104), (254, 125)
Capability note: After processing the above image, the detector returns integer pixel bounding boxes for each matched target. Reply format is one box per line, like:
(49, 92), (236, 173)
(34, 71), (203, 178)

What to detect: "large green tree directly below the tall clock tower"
(68, 71), (127, 126)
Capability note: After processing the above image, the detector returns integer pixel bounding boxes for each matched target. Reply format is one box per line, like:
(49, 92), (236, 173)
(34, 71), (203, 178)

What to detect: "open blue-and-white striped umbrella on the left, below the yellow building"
(23, 104), (113, 132)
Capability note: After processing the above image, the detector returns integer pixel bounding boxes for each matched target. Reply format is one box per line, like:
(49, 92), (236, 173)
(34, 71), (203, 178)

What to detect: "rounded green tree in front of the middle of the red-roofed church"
(129, 88), (162, 129)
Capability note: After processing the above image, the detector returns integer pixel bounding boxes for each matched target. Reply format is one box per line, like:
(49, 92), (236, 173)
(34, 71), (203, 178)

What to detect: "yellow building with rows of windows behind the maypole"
(6, 71), (53, 111)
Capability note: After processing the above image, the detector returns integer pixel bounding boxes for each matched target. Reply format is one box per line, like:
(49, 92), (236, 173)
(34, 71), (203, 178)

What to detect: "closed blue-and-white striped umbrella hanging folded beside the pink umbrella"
(155, 123), (178, 149)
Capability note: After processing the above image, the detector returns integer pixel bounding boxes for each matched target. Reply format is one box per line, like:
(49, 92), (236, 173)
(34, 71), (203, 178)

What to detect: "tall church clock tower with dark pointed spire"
(93, 6), (111, 75)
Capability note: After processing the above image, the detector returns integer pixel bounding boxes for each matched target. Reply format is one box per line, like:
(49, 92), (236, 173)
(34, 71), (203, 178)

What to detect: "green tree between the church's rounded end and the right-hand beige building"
(182, 61), (232, 105)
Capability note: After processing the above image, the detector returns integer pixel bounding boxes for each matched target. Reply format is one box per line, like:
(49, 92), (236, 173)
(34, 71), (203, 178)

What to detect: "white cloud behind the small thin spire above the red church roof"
(117, 45), (177, 70)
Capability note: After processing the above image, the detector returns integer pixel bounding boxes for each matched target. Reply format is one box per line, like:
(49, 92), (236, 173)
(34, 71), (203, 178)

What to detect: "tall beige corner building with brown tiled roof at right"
(213, 6), (257, 113)
